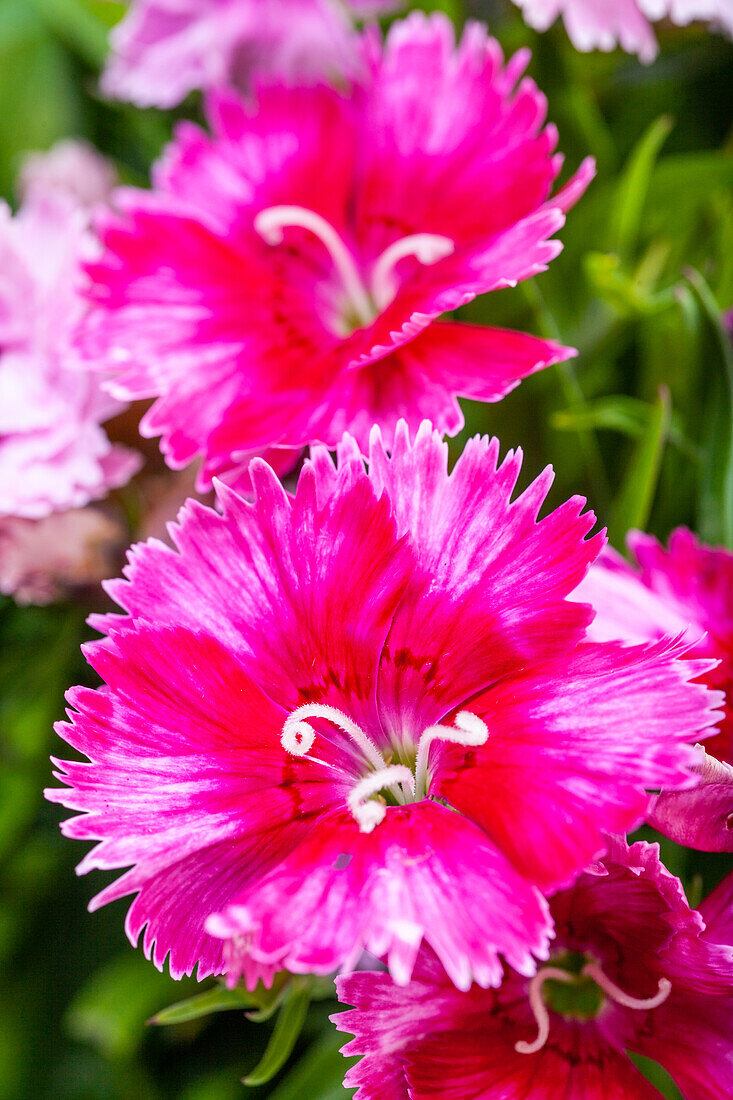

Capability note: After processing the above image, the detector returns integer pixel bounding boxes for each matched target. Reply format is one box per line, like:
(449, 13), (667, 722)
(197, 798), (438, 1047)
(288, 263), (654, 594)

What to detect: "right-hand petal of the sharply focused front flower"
(429, 641), (721, 890)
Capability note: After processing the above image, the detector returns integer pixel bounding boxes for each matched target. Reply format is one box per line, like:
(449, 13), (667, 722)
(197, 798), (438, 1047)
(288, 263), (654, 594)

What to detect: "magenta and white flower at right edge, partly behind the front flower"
(573, 527), (733, 763)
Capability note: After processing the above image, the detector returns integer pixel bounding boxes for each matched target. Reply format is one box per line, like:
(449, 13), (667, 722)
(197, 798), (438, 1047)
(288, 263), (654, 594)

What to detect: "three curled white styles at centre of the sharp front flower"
(281, 703), (489, 833)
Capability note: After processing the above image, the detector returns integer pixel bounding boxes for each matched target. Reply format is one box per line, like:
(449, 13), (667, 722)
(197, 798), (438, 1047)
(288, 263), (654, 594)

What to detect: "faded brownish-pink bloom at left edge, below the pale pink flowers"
(0, 506), (123, 604)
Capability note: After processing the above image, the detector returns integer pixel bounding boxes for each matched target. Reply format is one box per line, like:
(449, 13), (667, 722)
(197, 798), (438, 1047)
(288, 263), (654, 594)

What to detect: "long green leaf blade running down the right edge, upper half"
(687, 271), (733, 547)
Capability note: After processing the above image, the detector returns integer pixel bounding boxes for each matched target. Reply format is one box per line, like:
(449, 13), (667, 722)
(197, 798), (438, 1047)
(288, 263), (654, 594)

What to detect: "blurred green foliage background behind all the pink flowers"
(0, 0), (733, 1100)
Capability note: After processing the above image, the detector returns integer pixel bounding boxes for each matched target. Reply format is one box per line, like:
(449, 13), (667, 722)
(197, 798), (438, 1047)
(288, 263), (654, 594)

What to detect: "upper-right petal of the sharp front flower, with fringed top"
(370, 425), (603, 740)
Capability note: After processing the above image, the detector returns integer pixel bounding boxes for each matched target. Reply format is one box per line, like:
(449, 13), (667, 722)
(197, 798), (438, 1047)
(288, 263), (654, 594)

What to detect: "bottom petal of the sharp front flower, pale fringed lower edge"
(207, 802), (550, 989)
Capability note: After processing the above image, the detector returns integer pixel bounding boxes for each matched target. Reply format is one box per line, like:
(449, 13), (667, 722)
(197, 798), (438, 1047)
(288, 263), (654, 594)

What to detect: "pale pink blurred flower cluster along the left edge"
(0, 143), (140, 603)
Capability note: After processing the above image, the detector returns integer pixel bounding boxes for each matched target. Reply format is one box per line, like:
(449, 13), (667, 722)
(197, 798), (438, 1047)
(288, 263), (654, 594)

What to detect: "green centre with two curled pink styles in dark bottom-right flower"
(514, 953), (671, 1054)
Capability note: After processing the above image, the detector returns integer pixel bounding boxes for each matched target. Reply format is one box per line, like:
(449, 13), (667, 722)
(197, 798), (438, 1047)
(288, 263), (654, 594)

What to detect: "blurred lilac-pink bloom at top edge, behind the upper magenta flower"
(101, 0), (391, 107)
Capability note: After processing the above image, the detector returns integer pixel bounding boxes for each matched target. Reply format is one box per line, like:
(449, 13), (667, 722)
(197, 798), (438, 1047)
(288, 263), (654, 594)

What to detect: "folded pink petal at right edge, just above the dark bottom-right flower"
(648, 745), (733, 851)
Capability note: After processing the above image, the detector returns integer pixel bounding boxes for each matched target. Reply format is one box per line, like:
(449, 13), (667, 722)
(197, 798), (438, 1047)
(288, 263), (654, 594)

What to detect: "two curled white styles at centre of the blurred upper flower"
(254, 206), (456, 336)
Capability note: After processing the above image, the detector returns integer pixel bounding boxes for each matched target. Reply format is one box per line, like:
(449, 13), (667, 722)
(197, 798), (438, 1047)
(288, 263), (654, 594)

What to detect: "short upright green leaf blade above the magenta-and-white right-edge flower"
(609, 386), (670, 546)
